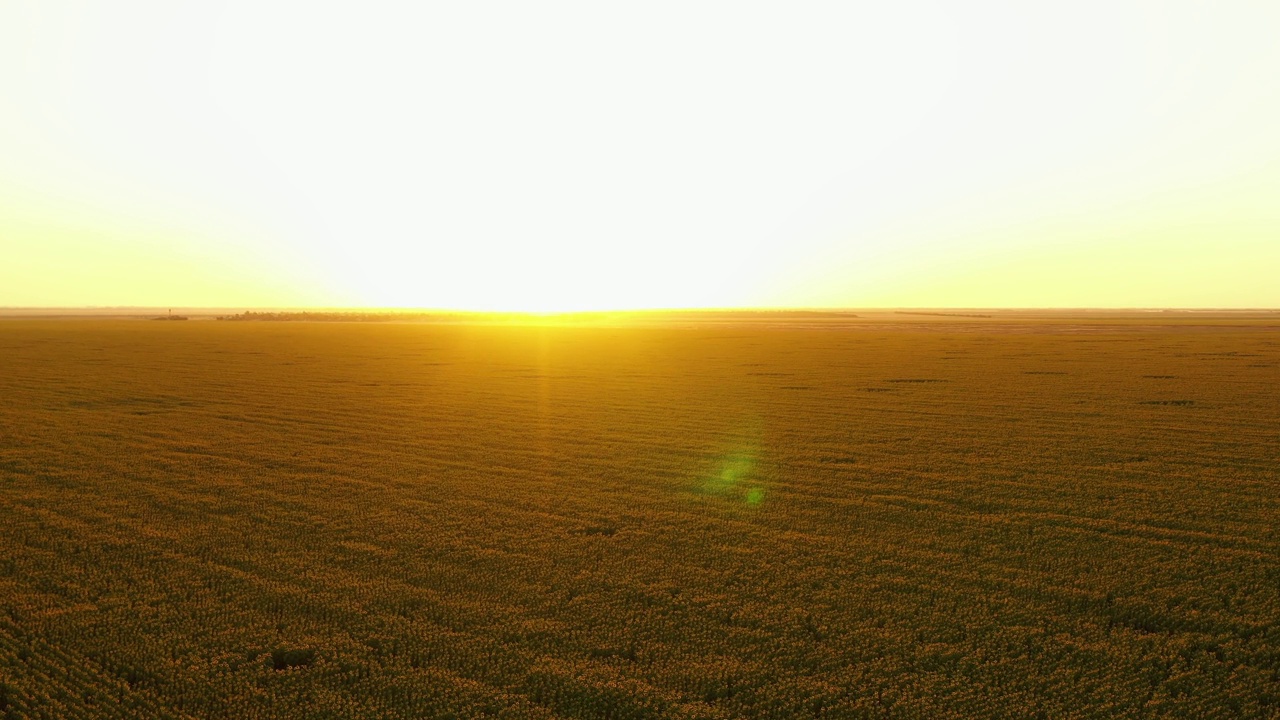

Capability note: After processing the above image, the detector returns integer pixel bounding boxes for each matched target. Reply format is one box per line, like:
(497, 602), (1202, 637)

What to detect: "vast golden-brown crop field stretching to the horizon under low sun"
(0, 315), (1280, 719)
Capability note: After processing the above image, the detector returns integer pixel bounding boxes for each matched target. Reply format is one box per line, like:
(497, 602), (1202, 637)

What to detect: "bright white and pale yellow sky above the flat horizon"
(0, 0), (1280, 311)
